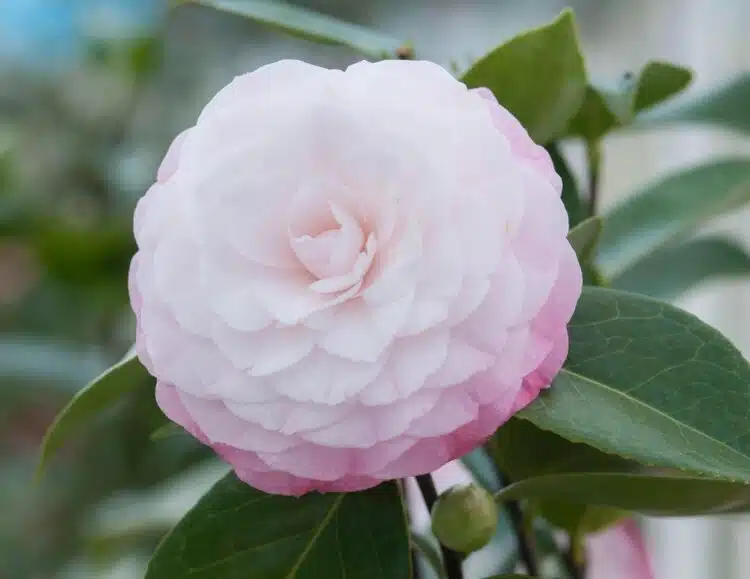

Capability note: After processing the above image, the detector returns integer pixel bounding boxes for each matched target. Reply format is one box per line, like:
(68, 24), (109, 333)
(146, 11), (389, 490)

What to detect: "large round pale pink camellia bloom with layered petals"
(130, 61), (581, 495)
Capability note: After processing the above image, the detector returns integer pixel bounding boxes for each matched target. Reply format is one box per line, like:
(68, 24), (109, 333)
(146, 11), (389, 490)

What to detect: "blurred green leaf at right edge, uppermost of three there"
(638, 73), (750, 133)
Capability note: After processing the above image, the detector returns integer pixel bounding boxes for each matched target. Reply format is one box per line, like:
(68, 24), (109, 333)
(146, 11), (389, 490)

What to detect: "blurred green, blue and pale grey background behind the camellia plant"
(0, 0), (750, 579)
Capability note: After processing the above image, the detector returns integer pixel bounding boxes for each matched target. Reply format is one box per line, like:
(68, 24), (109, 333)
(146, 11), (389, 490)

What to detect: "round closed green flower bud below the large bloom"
(432, 484), (498, 553)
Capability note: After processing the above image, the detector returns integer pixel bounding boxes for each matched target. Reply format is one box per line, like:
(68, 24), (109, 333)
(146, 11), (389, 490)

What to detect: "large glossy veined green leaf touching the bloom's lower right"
(519, 287), (750, 481)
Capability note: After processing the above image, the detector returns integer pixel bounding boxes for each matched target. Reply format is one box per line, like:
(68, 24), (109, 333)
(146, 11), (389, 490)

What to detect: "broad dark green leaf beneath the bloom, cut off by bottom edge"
(146, 474), (411, 579)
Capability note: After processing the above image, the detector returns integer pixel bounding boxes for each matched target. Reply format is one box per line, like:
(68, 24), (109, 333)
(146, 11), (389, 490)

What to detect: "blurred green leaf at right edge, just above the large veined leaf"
(611, 237), (750, 301)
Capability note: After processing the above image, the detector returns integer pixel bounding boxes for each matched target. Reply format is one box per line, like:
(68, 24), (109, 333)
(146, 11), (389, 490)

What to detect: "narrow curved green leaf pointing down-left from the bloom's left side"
(37, 350), (149, 475)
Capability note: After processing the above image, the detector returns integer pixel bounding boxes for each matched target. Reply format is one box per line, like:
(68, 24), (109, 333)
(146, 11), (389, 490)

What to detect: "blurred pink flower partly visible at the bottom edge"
(586, 519), (654, 579)
